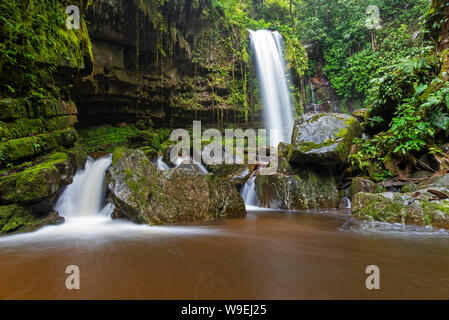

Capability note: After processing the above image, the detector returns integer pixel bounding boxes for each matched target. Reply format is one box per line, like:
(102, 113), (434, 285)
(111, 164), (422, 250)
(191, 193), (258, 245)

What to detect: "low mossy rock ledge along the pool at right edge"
(352, 191), (449, 229)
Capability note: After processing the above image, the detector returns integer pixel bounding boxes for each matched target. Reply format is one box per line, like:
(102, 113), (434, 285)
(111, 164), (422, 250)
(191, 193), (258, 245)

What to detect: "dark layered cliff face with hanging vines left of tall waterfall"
(72, 0), (258, 127)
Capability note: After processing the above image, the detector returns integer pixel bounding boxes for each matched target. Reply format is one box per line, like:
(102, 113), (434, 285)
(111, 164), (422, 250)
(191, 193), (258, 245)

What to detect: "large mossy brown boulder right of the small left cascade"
(108, 149), (246, 225)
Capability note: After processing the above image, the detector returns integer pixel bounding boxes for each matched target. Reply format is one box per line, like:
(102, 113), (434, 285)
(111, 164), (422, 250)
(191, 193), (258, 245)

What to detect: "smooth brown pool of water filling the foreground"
(0, 211), (449, 299)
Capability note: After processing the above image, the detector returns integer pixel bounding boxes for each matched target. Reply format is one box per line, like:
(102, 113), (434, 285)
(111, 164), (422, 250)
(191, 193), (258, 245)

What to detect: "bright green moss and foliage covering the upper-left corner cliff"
(0, 0), (83, 99)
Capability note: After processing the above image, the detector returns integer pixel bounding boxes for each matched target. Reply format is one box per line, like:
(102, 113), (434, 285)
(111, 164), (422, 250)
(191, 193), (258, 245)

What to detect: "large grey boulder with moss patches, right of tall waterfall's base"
(289, 113), (360, 165)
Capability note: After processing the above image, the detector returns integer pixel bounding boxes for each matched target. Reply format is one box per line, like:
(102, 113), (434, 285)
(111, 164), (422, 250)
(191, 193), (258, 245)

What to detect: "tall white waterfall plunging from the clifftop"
(249, 30), (294, 146)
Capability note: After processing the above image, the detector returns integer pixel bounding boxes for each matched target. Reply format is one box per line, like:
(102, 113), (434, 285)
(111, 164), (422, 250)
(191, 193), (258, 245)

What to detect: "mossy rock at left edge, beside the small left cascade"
(0, 153), (73, 204)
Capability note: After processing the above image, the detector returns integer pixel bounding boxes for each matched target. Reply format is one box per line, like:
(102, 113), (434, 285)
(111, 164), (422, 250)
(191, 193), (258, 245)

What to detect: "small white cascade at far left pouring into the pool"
(55, 156), (112, 222)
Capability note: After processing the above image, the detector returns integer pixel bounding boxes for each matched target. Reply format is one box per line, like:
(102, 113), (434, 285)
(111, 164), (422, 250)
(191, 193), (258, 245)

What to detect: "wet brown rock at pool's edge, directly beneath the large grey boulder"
(255, 168), (339, 210)
